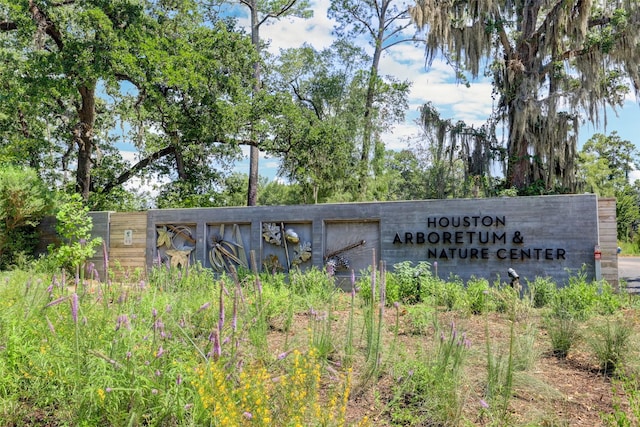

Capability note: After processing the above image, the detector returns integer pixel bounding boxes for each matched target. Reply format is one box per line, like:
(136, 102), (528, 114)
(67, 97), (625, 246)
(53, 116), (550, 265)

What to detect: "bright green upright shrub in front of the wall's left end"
(49, 193), (102, 272)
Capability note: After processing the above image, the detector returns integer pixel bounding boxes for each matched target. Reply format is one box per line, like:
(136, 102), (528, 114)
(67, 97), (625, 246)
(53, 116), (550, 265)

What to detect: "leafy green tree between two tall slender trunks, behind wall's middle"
(266, 42), (367, 203)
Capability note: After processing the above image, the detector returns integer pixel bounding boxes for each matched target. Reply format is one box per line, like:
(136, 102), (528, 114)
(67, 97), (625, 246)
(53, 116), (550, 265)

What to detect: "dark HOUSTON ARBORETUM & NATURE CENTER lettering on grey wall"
(393, 215), (566, 261)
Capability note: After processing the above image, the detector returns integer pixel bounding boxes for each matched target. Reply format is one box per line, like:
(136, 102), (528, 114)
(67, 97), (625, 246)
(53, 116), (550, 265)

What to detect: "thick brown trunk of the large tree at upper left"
(74, 82), (96, 201)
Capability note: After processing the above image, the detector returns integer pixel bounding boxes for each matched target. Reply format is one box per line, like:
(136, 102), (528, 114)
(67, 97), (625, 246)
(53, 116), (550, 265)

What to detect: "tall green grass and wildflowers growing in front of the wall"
(0, 264), (632, 426)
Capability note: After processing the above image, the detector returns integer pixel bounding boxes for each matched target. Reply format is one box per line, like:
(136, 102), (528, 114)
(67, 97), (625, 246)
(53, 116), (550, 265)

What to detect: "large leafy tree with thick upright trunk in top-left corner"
(0, 0), (151, 200)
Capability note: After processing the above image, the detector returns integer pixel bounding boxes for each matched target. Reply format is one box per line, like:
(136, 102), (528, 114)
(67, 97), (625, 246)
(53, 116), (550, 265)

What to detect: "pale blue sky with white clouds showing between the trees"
(124, 0), (640, 186)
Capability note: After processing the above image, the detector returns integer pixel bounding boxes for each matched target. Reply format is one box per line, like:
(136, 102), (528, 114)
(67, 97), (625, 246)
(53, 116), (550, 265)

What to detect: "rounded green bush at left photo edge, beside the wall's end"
(0, 166), (51, 268)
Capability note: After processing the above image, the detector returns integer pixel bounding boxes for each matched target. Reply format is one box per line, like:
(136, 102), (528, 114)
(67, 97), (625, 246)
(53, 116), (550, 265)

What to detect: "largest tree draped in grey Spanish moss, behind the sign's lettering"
(410, 0), (640, 192)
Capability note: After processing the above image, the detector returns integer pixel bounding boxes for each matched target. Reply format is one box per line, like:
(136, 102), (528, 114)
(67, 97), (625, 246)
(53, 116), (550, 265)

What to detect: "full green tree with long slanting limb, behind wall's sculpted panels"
(112, 21), (256, 207)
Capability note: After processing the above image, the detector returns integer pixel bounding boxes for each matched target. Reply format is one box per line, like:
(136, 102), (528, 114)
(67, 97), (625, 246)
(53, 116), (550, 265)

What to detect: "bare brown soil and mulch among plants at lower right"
(270, 300), (640, 427)
